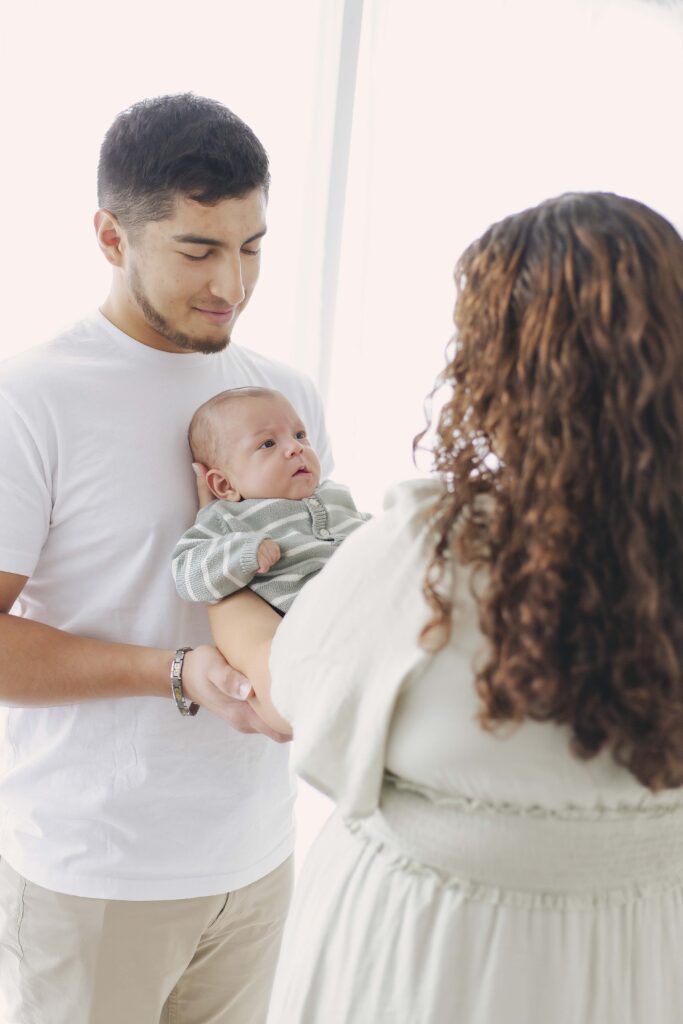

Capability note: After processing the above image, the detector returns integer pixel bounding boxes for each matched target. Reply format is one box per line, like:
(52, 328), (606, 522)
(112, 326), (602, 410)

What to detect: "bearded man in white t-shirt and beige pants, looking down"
(0, 95), (330, 1024)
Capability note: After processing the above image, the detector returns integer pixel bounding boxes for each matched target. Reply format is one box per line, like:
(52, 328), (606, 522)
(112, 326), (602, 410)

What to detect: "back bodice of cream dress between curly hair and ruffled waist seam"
(386, 593), (683, 815)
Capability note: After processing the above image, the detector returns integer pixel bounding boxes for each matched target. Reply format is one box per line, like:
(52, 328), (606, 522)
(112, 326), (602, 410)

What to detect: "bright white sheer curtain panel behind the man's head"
(0, 0), (344, 376)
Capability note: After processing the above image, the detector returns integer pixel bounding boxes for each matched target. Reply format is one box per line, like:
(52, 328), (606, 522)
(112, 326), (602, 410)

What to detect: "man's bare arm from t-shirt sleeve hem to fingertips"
(0, 572), (285, 740)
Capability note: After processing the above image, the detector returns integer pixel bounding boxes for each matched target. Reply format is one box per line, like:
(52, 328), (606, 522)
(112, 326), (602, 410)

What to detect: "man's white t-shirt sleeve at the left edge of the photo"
(0, 395), (52, 577)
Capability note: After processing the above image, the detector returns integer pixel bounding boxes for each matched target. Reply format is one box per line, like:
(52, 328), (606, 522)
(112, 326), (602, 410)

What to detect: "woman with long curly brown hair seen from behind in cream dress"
(211, 194), (683, 1024)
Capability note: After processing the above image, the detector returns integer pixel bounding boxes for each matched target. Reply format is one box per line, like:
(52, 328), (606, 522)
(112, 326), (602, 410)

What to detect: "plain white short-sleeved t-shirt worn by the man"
(0, 313), (331, 900)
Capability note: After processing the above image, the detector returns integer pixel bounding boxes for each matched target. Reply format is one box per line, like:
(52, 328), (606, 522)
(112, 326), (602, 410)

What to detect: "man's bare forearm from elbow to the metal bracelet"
(0, 612), (173, 708)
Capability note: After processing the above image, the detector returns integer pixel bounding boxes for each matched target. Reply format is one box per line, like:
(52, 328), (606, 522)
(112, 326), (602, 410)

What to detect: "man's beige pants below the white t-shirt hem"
(0, 858), (292, 1024)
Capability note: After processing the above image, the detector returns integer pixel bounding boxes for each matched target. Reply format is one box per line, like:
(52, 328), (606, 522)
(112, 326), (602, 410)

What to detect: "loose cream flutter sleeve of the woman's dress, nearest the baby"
(270, 481), (437, 817)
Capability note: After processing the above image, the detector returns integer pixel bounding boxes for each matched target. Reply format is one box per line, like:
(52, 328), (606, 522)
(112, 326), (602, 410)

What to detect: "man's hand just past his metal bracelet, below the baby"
(182, 644), (292, 743)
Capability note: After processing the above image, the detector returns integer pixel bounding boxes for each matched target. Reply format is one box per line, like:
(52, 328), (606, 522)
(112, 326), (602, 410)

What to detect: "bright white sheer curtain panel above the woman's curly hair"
(323, 0), (683, 511)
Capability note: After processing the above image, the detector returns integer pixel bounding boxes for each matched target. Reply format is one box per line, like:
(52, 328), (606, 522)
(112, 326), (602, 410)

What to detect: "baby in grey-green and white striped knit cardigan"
(173, 387), (371, 614)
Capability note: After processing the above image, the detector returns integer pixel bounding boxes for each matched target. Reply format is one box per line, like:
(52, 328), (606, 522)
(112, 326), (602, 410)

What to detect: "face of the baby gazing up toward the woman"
(217, 394), (321, 501)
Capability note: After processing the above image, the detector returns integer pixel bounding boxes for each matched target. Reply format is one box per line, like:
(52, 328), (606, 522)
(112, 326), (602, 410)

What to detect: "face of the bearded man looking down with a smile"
(123, 188), (265, 352)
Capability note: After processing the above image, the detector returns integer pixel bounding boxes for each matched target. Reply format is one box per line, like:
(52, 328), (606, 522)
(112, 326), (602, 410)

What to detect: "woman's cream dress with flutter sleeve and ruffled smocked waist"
(268, 481), (683, 1024)
